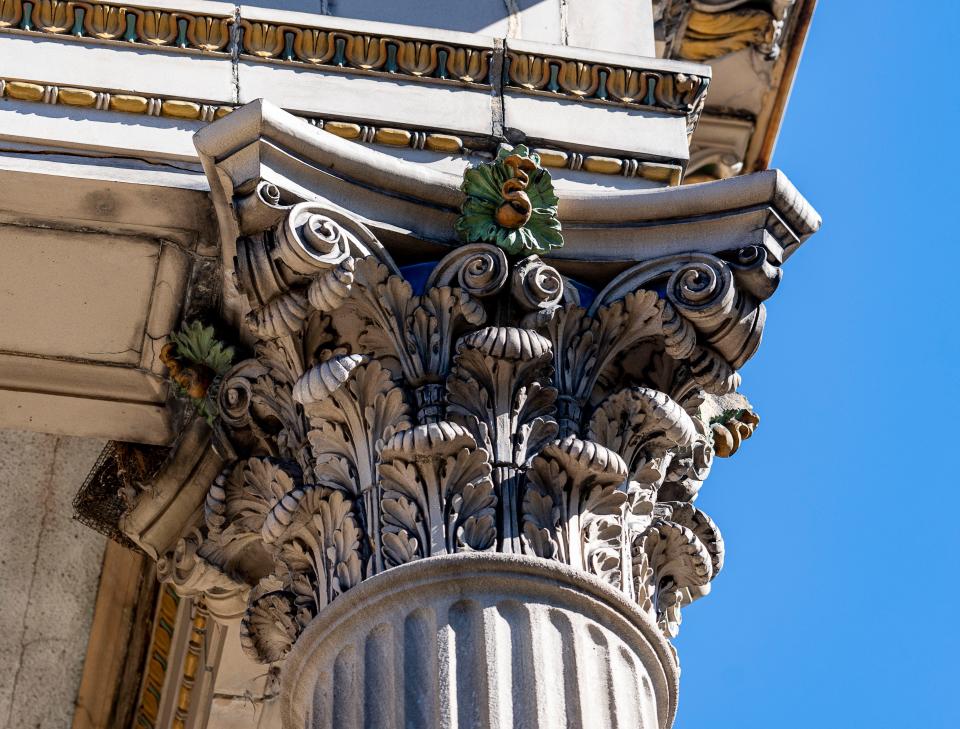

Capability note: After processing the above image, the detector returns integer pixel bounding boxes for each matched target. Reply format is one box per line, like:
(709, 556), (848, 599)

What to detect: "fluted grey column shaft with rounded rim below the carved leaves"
(281, 554), (679, 729)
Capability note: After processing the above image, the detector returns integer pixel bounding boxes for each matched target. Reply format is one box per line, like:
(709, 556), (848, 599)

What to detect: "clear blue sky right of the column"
(675, 0), (960, 729)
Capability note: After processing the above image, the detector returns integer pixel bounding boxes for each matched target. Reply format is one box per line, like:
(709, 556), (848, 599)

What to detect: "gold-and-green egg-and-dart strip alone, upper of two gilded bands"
(0, 0), (709, 125)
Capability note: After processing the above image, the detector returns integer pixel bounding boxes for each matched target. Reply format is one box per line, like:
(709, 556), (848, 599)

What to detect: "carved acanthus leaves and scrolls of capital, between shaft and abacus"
(150, 191), (780, 662)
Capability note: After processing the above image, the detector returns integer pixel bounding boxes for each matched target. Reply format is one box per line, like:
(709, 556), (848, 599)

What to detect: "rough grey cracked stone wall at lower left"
(0, 430), (106, 729)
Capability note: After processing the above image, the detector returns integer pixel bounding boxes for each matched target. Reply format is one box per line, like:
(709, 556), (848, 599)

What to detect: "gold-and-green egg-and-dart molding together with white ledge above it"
(0, 0), (710, 124)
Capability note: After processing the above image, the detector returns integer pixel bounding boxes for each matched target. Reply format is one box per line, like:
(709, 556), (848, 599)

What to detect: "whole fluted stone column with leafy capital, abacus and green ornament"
(125, 106), (819, 729)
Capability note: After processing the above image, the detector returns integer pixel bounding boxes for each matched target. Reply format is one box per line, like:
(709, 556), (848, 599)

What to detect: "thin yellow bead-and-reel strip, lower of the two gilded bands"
(0, 75), (682, 185)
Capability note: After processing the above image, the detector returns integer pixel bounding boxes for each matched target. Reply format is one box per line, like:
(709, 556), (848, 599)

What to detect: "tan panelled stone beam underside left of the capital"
(0, 156), (212, 443)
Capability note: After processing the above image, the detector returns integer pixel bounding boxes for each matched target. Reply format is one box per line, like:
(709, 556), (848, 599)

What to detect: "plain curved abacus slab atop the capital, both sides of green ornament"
(196, 102), (820, 288)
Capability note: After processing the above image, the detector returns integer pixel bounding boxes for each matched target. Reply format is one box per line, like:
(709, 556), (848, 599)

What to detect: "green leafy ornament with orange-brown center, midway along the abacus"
(456, 144), (563, 254)
